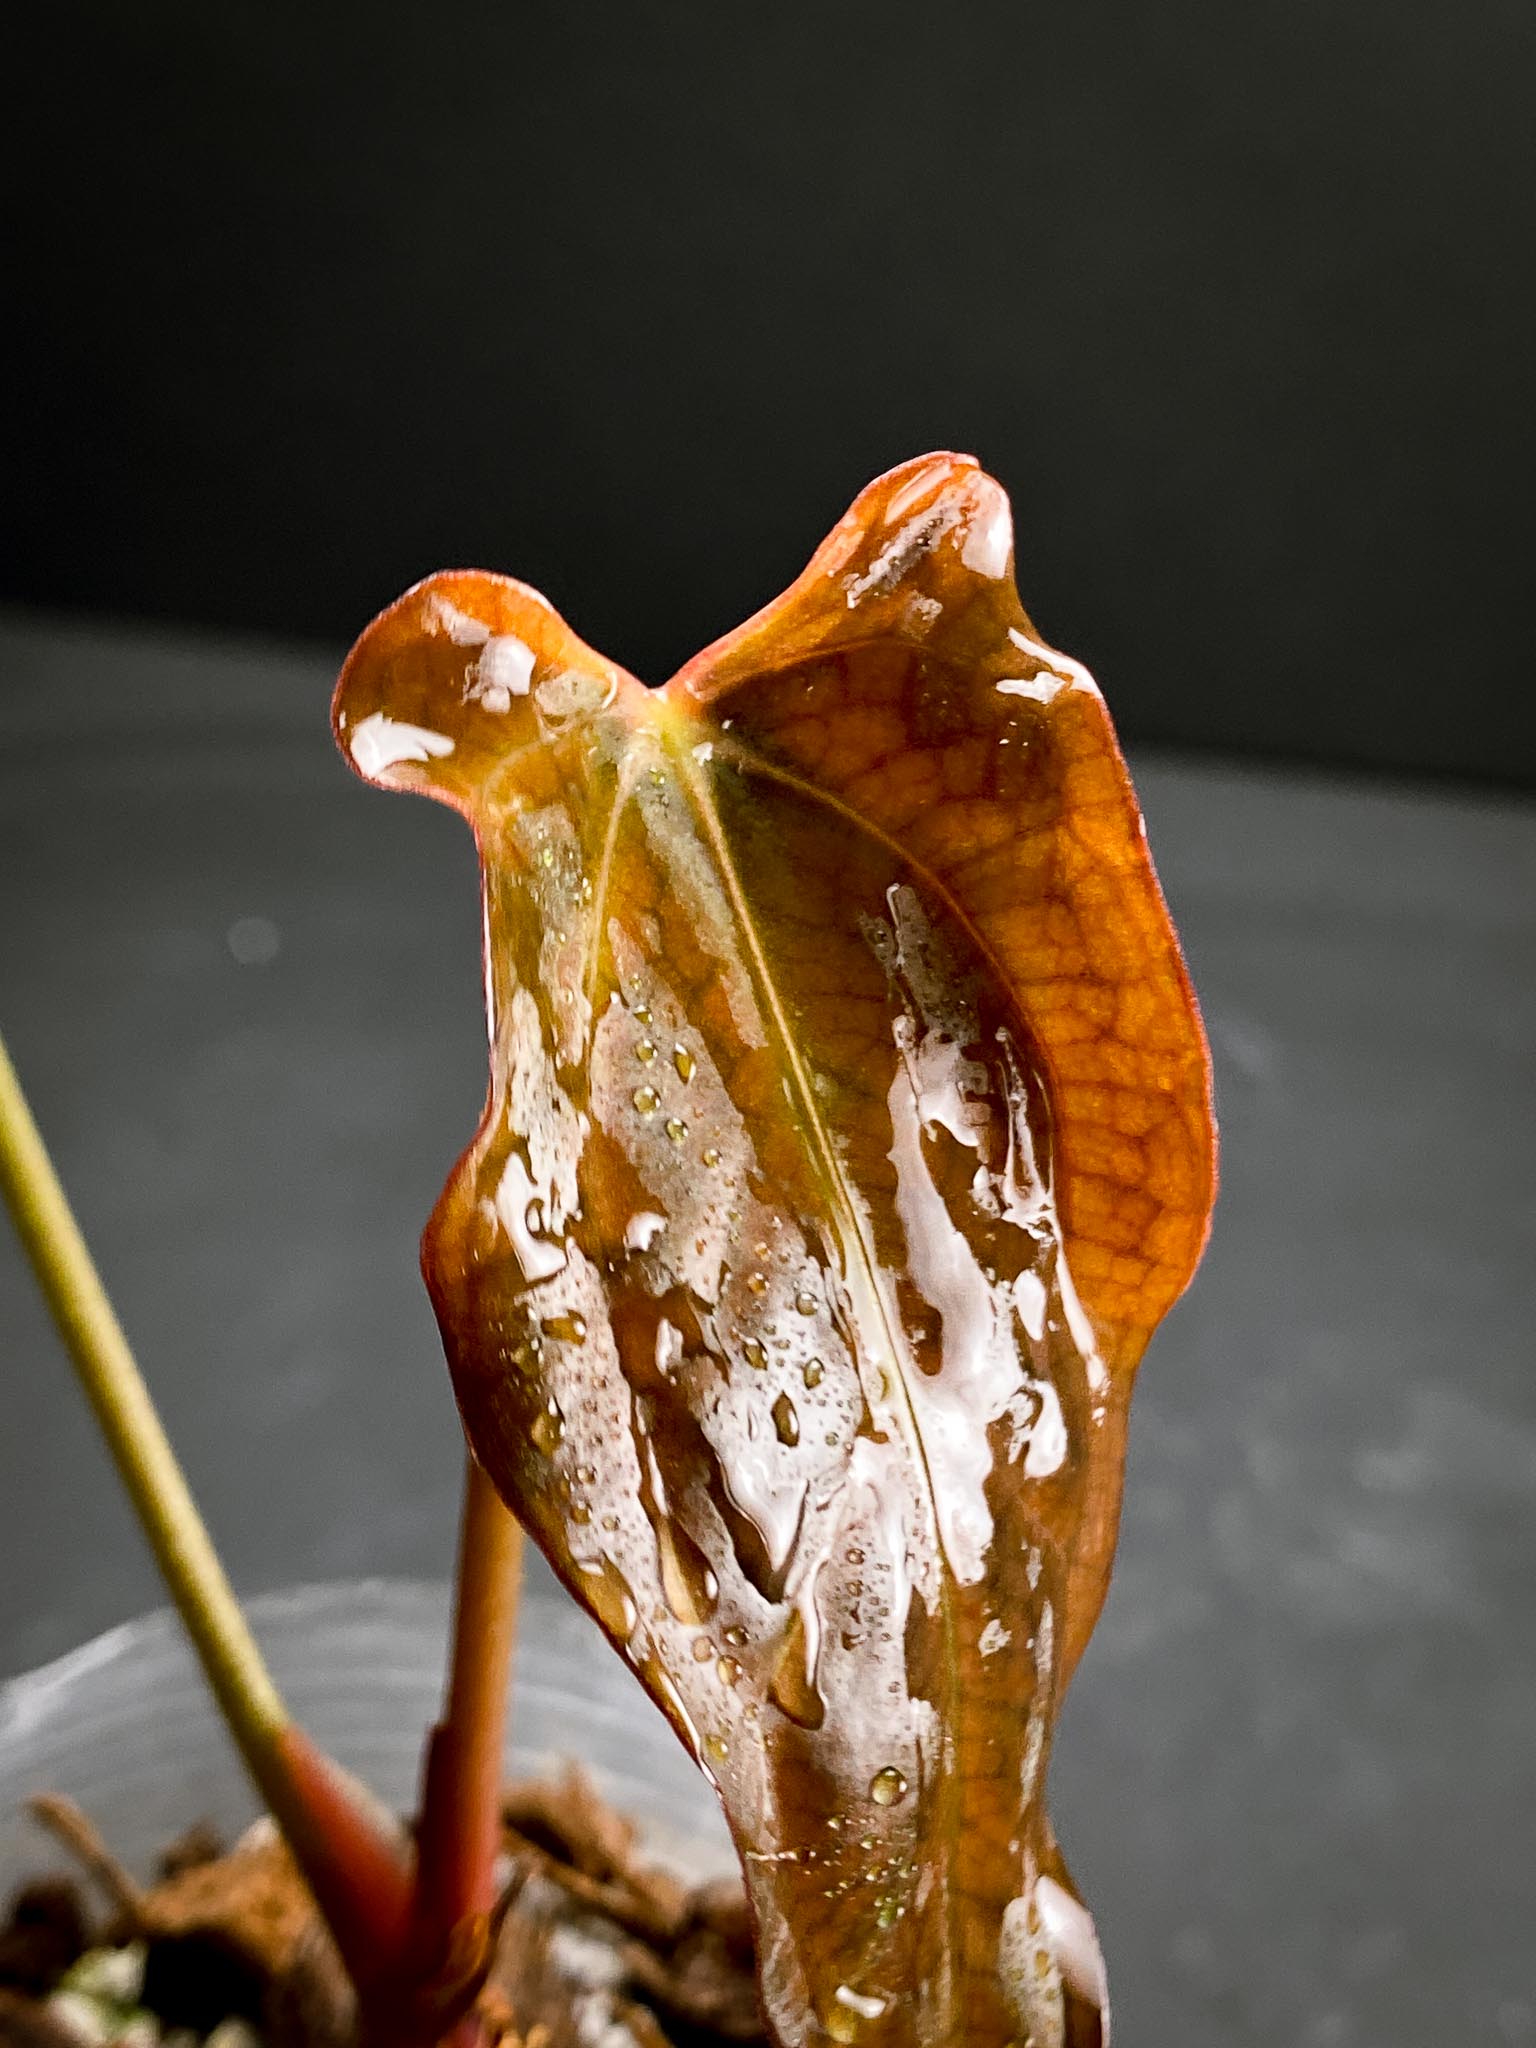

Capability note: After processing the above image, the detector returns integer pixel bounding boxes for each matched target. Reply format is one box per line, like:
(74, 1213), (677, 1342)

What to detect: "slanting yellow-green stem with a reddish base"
(0, 1038), (415, 1968)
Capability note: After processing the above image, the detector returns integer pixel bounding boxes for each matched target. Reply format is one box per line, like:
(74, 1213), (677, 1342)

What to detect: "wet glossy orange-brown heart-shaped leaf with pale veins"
(336, 455), (1214, 2048)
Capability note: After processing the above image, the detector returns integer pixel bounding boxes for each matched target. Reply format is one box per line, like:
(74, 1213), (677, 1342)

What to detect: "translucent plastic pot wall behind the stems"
(0, 1579), (735, 1888)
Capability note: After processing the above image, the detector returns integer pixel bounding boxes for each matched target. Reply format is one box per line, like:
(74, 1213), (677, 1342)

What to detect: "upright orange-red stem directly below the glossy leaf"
(416, 1454), (522, 1942)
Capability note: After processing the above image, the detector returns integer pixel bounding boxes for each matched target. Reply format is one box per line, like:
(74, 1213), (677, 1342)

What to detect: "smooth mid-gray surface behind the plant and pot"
(0, 623), (1536, 2048)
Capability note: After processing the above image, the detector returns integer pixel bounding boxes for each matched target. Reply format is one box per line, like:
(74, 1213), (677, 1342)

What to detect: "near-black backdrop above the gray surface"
(0, 0), (1536, 782)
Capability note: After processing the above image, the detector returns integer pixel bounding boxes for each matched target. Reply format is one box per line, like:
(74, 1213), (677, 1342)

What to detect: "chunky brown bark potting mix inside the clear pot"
(0, 1769), (764, 2048)
